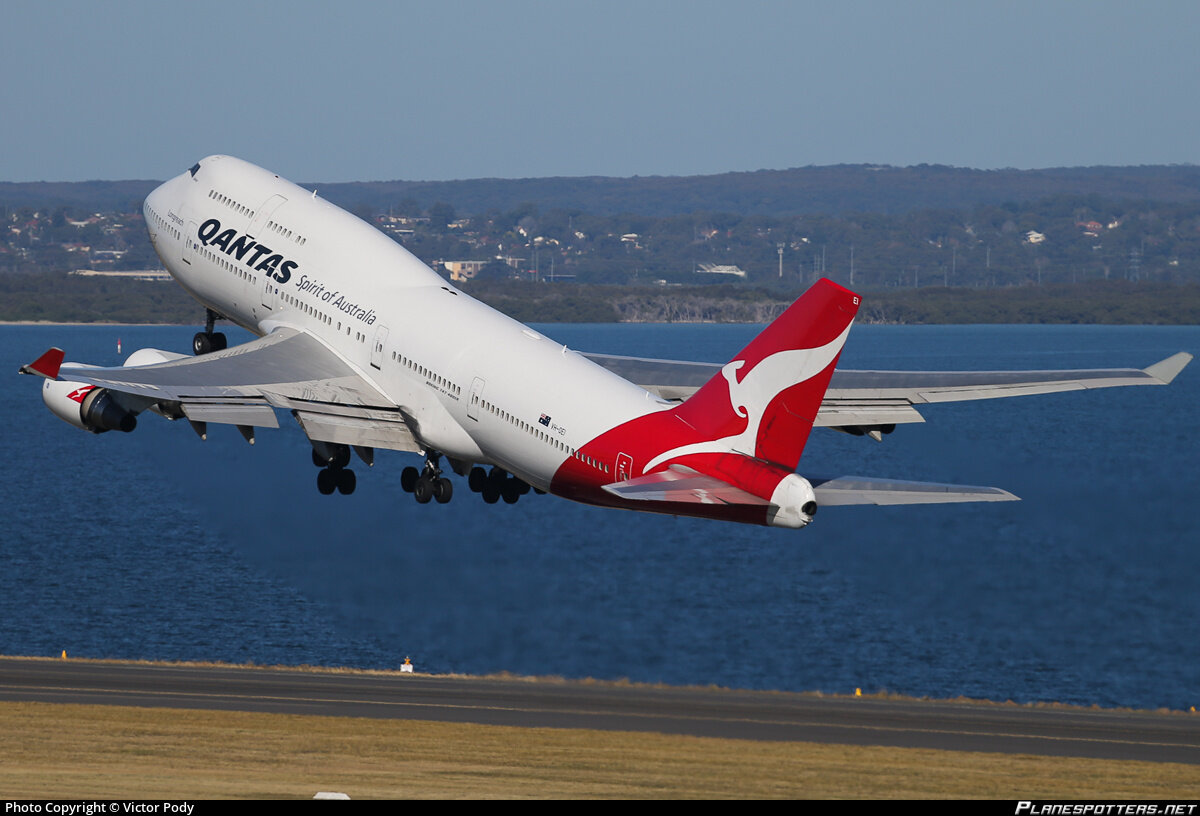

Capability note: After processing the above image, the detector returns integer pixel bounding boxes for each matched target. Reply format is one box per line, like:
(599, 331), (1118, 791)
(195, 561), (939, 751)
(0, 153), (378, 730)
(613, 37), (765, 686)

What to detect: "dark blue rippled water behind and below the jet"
(0, 325), (1200, 708)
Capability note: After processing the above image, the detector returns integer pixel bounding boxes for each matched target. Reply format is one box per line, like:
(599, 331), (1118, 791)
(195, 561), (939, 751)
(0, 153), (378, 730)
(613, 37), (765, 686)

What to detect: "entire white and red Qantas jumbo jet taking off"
(22, 156), (1192, 527)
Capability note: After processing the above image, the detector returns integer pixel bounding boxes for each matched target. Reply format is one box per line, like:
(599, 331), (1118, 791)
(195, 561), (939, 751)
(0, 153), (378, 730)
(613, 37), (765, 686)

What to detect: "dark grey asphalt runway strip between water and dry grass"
(0, 658), (1200, 764)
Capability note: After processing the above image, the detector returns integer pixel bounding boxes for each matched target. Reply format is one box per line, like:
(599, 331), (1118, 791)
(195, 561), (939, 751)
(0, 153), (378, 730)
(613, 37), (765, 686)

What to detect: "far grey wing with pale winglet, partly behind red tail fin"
(584, 352), (1192, 432)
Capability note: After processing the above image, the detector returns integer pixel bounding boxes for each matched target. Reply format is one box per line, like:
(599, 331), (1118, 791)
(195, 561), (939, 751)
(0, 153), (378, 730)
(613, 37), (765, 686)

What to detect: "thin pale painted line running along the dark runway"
(0, 685), (1200, 749)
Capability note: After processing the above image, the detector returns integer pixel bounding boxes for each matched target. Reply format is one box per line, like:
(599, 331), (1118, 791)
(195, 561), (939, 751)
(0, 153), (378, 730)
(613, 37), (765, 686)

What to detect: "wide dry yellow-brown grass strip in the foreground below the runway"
(0, 702), (1200, 799)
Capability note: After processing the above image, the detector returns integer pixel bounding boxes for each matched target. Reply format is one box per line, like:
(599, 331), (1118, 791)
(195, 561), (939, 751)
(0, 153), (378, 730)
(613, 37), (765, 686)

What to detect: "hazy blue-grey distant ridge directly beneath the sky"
(7, 164), (1200, 217)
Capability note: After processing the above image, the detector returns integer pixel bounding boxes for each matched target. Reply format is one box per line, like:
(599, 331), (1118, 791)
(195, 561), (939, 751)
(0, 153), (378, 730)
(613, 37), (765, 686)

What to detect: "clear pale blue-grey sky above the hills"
(0, 0), (1200, 182)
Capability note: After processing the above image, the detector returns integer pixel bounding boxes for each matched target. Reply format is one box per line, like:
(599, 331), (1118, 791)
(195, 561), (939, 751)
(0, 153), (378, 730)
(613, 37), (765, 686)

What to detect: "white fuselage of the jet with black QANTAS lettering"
(145, 156), (668, 490)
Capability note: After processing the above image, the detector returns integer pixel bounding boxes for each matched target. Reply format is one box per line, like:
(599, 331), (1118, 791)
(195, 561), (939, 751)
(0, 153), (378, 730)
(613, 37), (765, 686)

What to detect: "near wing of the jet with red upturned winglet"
(22, 329), (421, 451)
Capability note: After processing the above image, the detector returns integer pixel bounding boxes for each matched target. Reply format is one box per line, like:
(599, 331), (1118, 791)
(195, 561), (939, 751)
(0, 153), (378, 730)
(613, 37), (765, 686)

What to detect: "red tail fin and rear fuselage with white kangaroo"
(554, 280), (859, 513)
